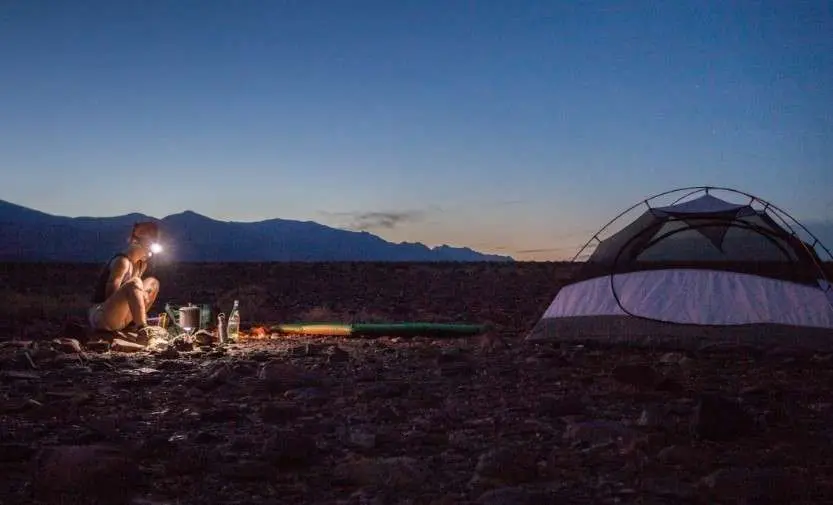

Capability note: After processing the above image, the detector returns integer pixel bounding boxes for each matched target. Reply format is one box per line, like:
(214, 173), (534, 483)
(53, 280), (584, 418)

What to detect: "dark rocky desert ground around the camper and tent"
(0, 264), (833, 505)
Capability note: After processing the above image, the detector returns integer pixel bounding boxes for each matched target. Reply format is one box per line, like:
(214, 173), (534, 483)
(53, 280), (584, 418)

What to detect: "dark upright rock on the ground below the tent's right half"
(690, 394), (755, 441)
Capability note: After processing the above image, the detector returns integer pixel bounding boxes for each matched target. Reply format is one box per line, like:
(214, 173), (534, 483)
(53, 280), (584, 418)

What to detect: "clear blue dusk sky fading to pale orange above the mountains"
(0, 0), (833, 259)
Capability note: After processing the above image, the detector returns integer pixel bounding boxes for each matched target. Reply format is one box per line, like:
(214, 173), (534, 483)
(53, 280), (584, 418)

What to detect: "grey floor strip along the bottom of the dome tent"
(526, 316), (833, 352)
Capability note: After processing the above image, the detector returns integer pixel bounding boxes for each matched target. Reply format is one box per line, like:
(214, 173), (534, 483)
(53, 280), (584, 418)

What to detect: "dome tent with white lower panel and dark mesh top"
(527, 186), (833, 349)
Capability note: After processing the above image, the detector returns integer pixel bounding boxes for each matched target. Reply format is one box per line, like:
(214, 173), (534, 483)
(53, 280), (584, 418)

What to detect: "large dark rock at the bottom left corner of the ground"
(33, 445), (140, 503)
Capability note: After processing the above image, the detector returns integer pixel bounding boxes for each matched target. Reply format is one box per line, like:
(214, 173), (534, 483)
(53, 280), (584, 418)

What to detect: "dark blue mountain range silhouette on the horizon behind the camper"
(0, 200), (513, 263)
